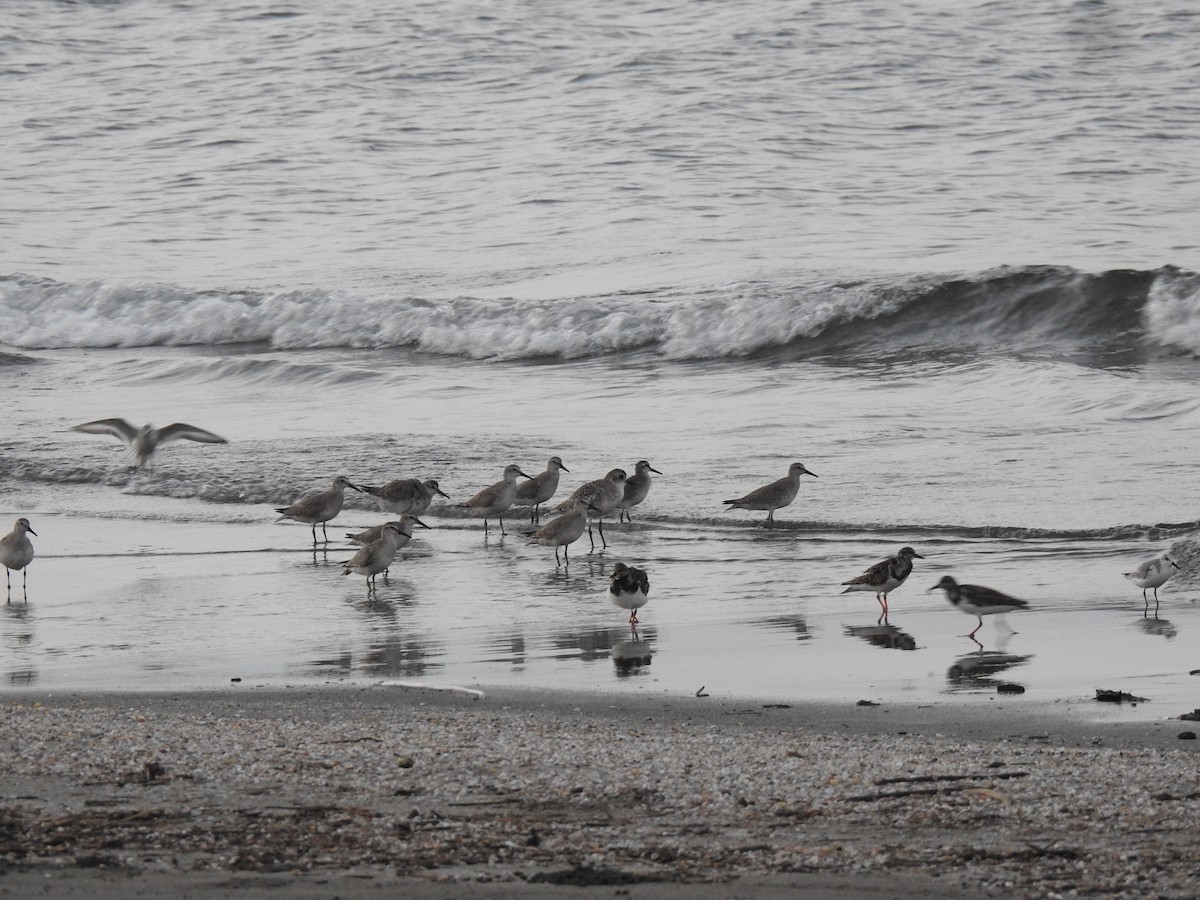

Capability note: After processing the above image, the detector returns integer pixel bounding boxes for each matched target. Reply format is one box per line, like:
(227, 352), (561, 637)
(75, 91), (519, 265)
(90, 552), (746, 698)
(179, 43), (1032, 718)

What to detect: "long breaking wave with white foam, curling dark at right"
(0, 266), (1200, 360)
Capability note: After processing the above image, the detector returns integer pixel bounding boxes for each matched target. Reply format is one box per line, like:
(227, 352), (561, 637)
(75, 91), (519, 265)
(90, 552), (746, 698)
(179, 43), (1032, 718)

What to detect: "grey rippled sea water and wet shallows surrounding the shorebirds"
(0, 0), (1200, 716)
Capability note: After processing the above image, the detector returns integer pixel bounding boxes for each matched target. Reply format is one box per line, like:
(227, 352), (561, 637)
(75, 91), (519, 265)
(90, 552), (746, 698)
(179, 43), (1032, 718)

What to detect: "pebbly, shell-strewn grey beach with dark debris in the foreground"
(0, 686), (1200, 898)
